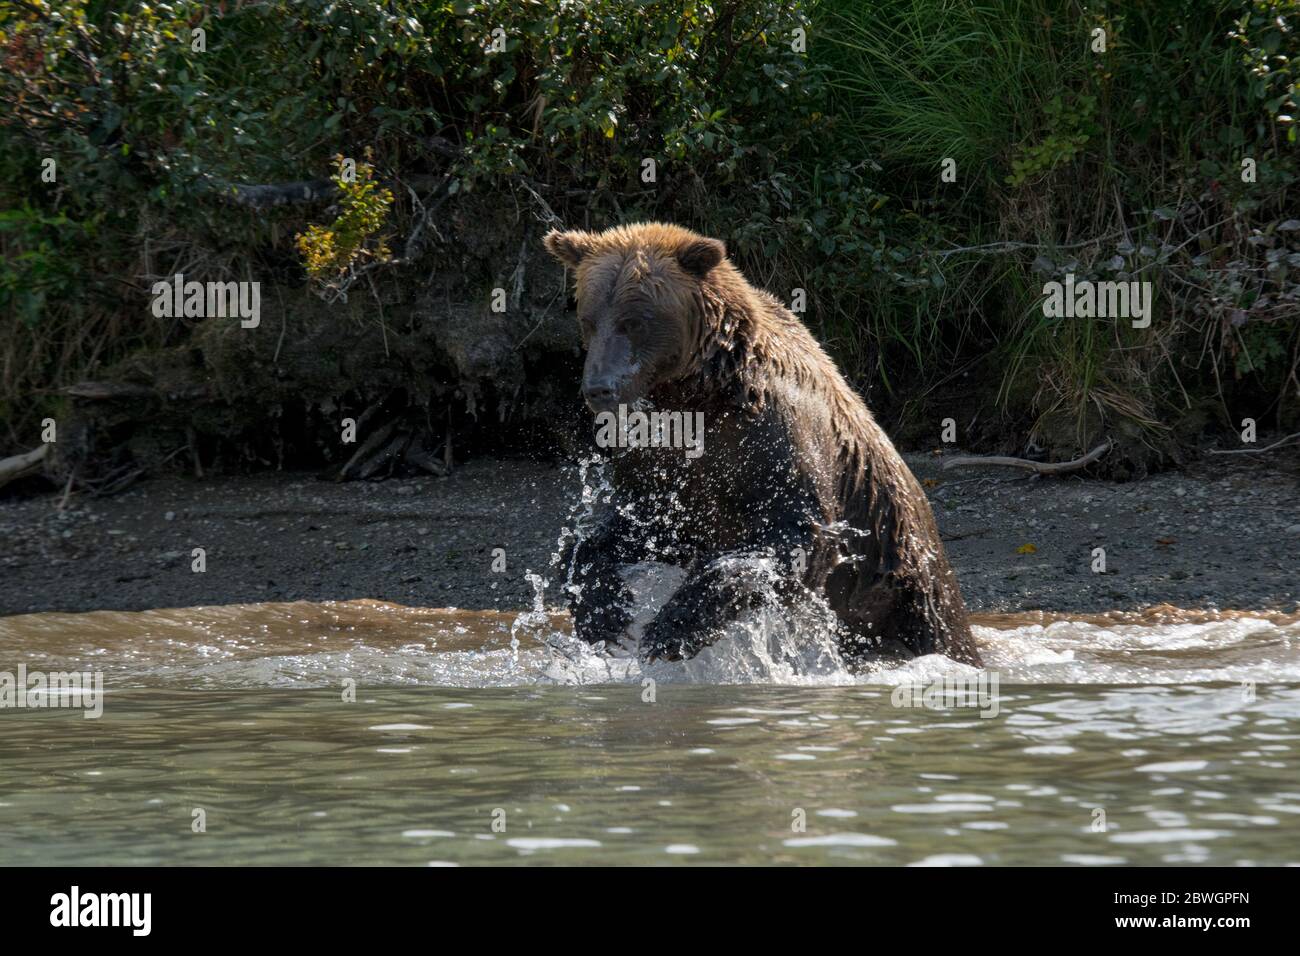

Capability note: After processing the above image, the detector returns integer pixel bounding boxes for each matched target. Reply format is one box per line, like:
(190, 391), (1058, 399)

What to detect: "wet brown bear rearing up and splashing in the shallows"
(545, 222), (980, 666)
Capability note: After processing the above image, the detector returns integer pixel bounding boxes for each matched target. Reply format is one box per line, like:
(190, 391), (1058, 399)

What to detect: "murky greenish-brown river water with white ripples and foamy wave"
(0, 601), (1300, 865)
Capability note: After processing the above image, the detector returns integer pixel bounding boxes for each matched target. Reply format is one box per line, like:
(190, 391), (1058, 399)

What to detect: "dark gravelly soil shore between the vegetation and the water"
(0, 450), (1300, 614)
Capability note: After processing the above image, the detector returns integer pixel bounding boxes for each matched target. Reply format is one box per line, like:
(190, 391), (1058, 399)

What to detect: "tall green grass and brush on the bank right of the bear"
(819, 0), (1300, 463)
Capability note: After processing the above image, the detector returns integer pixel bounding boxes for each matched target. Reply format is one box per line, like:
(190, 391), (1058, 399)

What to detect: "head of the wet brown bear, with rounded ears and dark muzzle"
(543, 222), (727, 412)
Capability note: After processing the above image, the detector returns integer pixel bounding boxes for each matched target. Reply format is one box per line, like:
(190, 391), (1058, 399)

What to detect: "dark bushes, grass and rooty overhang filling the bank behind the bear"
(0, 0), (1300, 481)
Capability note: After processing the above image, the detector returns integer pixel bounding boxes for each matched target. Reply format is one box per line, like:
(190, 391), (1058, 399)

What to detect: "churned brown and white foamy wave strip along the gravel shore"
(0, 598), (1300, 693)
